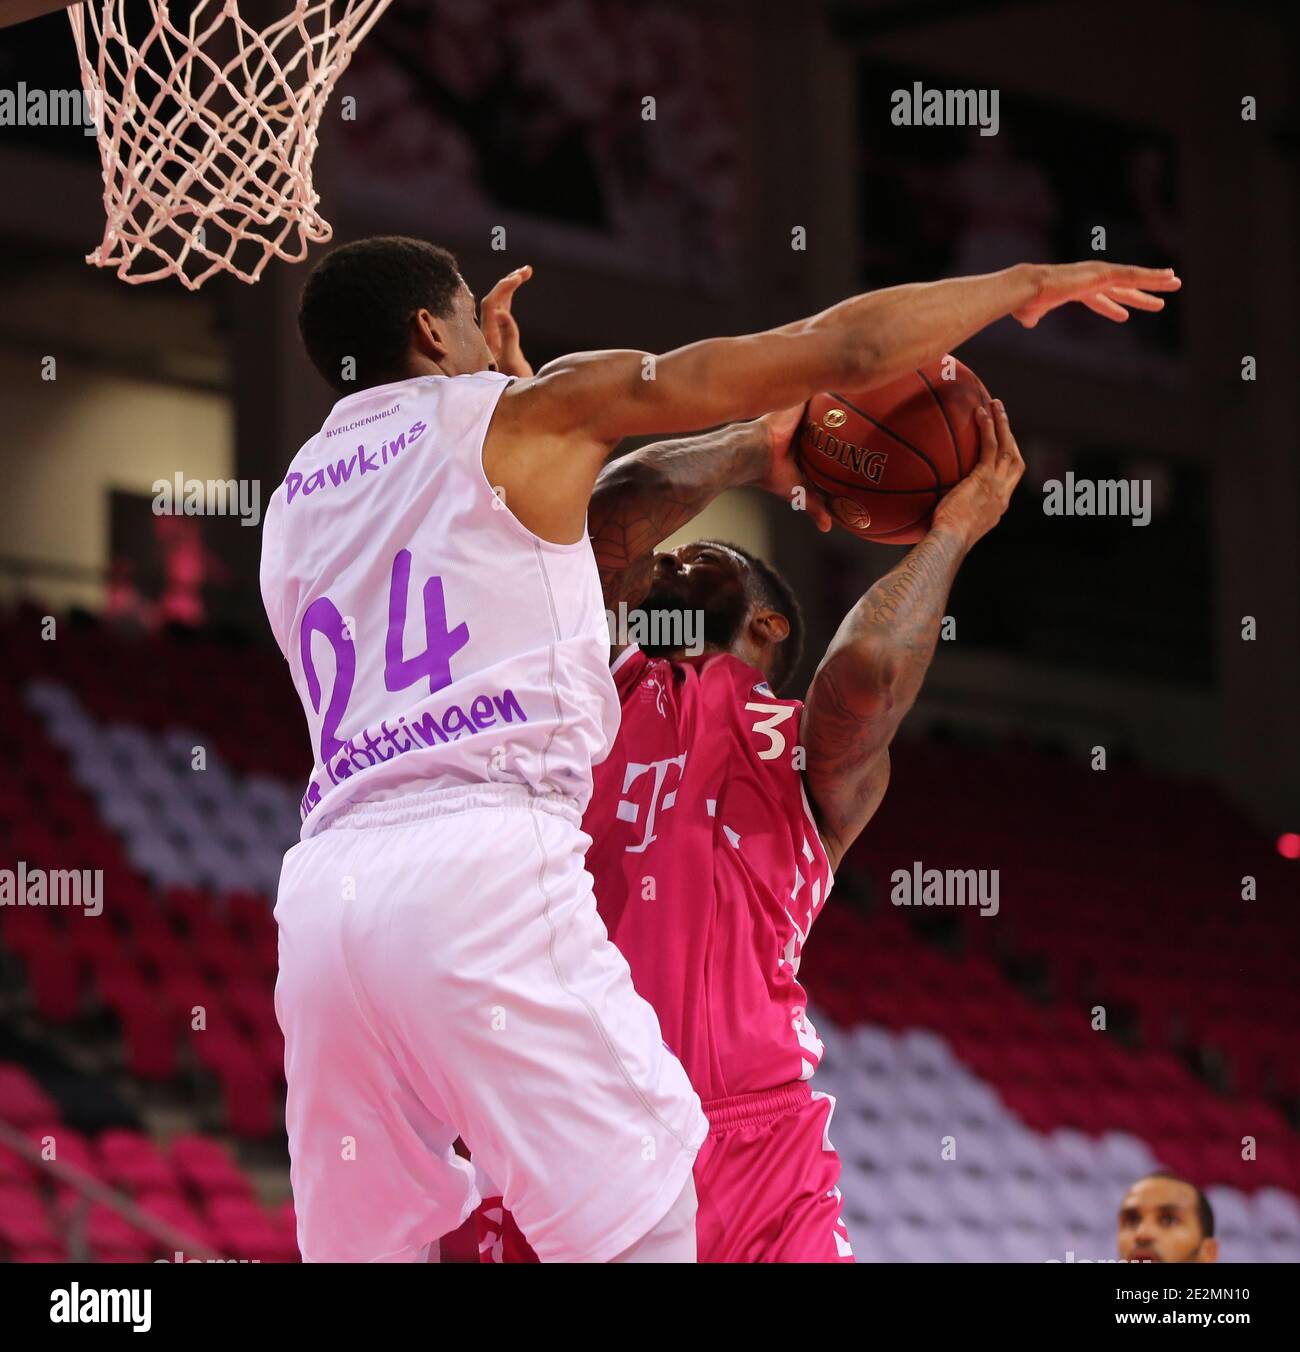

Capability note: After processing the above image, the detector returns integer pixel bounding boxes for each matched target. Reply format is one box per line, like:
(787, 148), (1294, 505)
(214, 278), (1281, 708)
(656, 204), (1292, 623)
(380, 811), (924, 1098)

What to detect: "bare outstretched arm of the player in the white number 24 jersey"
(484, 262), (1180, 544)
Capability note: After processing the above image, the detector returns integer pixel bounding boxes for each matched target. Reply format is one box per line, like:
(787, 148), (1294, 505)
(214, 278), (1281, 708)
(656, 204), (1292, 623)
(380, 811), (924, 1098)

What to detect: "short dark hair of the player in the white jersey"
(297, 235), (461, 393)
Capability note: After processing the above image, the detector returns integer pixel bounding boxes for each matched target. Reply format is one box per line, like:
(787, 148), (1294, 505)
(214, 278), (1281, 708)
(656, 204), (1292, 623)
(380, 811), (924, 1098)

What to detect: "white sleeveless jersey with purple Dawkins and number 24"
(261, 372), (619, 838)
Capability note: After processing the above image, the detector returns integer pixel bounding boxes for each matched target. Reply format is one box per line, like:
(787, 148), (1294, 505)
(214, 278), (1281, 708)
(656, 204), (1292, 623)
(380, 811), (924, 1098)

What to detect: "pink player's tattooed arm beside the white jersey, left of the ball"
(586, 404), (831, 608)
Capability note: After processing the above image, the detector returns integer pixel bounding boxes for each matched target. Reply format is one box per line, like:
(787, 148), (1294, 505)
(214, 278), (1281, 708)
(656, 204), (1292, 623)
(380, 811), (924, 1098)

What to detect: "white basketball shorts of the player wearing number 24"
(268, 786), (708, 1263)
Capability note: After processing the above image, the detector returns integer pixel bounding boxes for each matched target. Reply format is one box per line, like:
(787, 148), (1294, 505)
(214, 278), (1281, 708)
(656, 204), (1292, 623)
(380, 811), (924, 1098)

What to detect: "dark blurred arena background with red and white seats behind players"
(0, 0), (1300, 1314)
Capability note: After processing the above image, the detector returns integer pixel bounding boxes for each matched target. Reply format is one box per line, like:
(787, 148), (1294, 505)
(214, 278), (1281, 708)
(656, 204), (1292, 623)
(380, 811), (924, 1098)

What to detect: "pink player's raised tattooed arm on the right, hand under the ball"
(803, 400), (1024, 867)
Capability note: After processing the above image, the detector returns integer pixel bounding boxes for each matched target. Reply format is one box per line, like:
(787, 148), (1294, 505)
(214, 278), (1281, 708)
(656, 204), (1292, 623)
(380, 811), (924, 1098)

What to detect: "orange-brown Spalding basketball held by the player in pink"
(797, 357), (989, 545)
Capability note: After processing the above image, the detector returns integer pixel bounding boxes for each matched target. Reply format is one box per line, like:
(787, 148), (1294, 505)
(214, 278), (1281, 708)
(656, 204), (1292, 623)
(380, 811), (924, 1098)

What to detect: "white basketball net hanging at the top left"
(69, 0), (389, 291)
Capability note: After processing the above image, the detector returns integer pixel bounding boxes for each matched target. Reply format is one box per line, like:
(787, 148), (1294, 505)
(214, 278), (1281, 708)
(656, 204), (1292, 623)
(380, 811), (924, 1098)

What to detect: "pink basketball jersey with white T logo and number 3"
(582, 648), (832, 1101)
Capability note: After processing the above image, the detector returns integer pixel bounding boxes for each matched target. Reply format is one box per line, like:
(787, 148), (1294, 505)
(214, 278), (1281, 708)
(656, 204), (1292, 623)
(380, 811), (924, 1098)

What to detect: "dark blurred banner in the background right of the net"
(339, 0), (749, 292)
